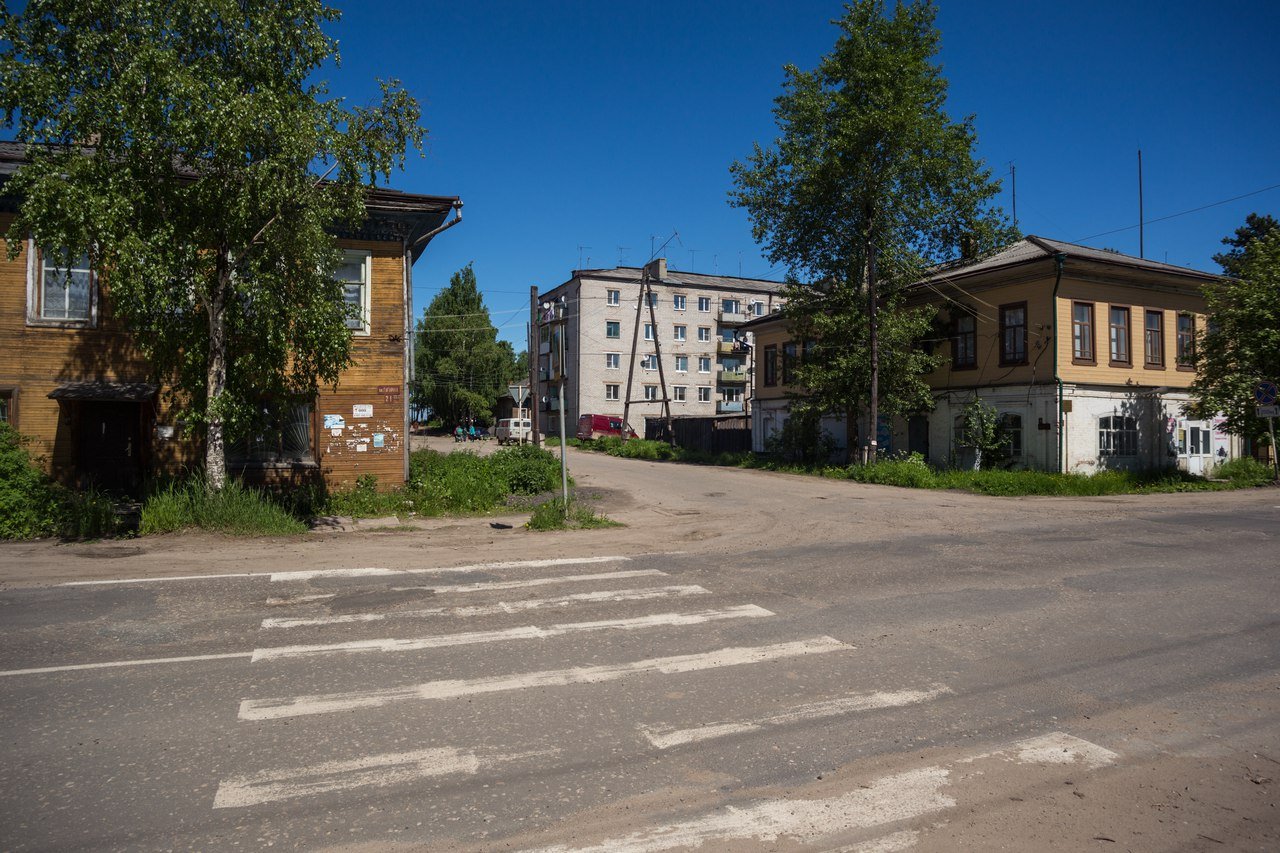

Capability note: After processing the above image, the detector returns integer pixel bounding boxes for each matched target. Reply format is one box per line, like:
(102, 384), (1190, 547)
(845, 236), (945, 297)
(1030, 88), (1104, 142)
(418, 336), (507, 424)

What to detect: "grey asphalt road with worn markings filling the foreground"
(0, 460), (1280, 853)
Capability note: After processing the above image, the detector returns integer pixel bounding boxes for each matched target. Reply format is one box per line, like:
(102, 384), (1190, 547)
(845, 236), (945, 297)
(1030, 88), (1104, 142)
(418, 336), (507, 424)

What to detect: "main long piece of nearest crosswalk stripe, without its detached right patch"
(524, 767), (956, 853)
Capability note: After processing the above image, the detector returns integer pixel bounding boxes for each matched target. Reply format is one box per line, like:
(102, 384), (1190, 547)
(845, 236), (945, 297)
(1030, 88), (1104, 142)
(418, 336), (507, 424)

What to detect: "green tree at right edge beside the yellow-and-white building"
(1188, 229), (1280, 448)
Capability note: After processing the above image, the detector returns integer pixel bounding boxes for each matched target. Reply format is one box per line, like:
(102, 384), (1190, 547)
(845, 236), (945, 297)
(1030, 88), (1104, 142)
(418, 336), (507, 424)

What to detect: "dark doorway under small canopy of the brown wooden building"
(76, 402), (142, 493)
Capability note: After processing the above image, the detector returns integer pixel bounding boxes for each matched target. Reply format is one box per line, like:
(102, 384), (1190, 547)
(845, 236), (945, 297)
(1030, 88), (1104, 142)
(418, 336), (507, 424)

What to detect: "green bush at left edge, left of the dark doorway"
(0, 423), (119, 539)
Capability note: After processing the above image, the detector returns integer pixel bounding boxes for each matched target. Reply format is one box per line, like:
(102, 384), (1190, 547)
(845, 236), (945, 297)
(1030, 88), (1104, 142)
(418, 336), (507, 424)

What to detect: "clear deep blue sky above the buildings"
(325, 0), (1280, 348)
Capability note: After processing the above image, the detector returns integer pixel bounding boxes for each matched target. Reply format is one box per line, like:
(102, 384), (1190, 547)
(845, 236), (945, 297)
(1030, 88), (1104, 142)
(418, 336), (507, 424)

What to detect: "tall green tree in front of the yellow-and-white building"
(730, 0), (1015, 459)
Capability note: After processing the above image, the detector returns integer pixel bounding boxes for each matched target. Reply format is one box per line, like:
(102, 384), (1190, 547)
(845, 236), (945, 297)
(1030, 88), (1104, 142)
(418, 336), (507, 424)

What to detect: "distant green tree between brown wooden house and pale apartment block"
(413, 264), (517, 427)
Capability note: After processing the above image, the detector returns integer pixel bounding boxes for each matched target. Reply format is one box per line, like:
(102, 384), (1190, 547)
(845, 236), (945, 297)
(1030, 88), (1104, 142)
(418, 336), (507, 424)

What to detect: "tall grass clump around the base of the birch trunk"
(138, 478), (307, 537)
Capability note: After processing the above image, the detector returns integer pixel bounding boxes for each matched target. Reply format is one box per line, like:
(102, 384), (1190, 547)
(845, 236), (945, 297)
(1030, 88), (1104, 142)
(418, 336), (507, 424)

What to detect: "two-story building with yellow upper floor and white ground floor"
(753, 237), (1238, 474)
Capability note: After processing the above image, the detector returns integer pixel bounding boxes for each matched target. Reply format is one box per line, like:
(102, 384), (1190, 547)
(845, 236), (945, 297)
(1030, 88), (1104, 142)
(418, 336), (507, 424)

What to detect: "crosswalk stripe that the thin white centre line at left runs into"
(253, 605), (773, 663)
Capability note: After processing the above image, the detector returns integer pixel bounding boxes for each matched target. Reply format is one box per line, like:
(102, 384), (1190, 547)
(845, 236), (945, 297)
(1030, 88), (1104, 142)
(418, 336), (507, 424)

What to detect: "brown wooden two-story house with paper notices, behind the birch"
(0, 143), (461, 491)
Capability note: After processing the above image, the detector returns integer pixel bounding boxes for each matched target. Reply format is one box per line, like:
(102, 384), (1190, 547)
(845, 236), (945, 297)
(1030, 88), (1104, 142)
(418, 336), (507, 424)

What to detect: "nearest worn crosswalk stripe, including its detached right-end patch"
(527, 731), (1116, 853)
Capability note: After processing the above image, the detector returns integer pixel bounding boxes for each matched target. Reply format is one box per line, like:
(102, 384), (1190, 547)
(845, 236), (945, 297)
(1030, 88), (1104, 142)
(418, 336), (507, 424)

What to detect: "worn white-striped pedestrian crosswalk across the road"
(212, 557), (1114, 853)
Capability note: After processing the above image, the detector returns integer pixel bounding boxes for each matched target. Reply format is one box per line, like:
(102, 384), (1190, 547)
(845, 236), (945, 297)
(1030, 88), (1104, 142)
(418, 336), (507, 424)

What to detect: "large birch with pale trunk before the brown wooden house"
(0, 0), (422, 488)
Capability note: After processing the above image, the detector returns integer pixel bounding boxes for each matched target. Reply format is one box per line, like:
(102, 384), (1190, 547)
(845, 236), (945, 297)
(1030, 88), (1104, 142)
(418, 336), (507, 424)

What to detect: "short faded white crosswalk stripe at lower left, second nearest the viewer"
(214, 748), (547, 808)
